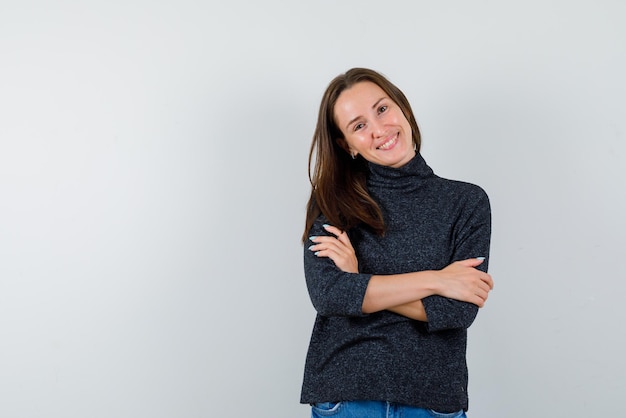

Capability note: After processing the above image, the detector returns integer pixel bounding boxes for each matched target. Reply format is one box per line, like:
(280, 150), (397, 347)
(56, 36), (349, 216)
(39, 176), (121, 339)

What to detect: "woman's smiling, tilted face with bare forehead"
(334, 81), (415, 168)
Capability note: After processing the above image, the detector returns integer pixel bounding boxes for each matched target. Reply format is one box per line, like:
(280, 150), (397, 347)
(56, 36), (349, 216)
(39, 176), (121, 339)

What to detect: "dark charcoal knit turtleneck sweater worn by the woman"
(301, 154), (491, 412)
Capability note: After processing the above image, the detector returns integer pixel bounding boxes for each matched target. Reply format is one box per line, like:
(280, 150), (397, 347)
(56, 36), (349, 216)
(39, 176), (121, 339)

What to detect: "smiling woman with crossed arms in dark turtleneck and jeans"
(301, 68), (493, 418)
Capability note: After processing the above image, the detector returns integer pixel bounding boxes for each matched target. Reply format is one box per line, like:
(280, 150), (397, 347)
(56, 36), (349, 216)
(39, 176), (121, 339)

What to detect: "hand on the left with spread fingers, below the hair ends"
(309, 225), (359, 273)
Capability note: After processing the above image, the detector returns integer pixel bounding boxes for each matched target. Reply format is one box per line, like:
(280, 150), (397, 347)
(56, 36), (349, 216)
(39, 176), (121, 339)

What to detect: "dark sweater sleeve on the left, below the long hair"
(304, 217), (371, 316)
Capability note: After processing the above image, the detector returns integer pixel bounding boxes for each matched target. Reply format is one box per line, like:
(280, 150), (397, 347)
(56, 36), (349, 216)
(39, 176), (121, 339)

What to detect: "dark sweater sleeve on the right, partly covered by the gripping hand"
(422, 185), (491, 332)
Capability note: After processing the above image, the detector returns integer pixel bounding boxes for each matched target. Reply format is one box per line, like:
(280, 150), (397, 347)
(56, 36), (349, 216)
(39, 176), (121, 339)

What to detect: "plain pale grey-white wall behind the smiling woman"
(0, 0), (626, 418)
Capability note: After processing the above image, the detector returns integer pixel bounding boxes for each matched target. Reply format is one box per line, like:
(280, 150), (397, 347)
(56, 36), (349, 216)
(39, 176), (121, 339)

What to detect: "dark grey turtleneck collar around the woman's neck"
(367, 152), (435, 189)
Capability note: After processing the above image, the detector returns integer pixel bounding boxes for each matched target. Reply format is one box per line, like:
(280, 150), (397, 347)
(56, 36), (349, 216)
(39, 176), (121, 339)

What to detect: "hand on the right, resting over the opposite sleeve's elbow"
(435, 258), (493, 308)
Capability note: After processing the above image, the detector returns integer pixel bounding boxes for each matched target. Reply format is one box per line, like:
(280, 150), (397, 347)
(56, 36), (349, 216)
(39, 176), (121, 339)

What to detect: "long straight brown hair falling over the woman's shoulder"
(302, 68), (421, 242)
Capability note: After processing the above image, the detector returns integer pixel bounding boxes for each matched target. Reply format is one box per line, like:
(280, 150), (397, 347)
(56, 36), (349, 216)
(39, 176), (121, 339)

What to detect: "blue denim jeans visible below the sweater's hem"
(311, 401), (467, 418)
